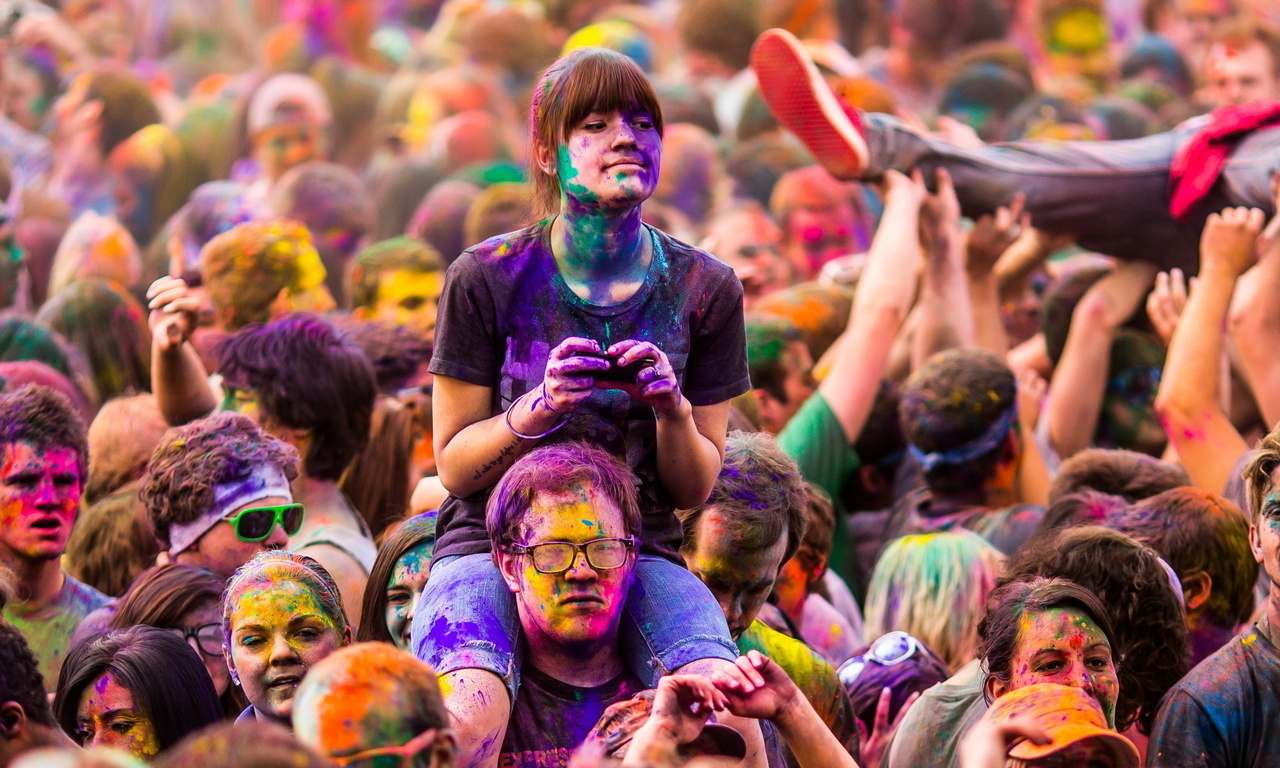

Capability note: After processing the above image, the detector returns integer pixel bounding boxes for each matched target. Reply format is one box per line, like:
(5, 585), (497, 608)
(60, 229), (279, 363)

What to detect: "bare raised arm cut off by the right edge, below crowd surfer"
(1228, 189), (1280, 428)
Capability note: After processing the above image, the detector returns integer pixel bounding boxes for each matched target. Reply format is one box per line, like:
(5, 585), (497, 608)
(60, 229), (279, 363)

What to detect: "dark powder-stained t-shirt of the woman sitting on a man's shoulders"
(430, 220), (750, 562)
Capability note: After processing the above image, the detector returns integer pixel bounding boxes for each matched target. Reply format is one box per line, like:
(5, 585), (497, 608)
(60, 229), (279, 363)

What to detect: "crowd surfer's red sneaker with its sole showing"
(751, 29), (868, 180)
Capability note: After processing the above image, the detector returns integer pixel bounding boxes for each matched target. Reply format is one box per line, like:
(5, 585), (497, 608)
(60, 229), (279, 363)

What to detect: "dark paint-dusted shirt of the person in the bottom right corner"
(1147, 616), (1280, 768)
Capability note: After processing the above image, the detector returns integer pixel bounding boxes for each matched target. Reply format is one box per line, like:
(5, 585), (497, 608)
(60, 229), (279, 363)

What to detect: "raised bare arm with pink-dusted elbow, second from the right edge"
(1156, 209), (1262, 493)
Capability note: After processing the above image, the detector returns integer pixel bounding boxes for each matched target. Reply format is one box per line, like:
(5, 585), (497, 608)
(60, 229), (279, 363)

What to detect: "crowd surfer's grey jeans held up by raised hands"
(864, 114), (1280, 274)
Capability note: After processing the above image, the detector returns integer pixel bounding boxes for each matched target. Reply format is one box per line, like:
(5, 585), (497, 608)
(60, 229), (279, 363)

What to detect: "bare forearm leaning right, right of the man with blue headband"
(1048, 261), (1156, 460)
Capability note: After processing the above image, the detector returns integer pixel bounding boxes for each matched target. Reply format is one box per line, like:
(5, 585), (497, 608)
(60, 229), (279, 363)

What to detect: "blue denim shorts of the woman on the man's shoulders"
(410, 554), (737, 701)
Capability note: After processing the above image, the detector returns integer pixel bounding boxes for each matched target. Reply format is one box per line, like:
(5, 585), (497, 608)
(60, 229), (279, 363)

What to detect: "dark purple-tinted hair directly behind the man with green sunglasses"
(218, 312), (376, 480)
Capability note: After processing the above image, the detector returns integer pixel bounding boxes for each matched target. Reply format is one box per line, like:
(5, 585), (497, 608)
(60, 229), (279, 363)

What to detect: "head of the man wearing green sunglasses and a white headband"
(138, 411), (303, 577)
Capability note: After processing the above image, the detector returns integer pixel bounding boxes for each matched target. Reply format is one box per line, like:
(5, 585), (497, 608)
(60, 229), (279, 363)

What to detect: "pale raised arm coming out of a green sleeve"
(818, 172), (925, 444)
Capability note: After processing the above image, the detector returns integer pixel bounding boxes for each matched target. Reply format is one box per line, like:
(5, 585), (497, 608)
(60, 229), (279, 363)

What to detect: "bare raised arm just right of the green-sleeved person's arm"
(911, 169), (974, 370)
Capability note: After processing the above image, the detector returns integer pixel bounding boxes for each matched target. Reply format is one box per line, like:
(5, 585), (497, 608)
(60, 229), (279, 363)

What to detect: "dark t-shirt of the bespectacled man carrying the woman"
(498, 663), (644, 768)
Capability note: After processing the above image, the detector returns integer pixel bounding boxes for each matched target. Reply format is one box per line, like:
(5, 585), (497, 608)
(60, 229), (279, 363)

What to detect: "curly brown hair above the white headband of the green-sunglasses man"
(138, 411), (298, 541)
